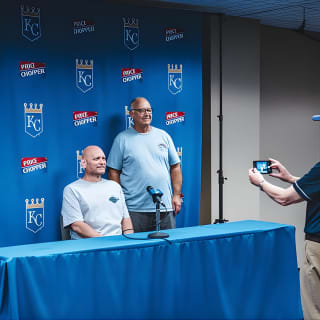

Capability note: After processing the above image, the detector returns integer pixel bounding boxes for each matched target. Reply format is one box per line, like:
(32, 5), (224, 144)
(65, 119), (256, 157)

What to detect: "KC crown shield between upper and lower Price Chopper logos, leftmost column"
(24, 103), (43, 138)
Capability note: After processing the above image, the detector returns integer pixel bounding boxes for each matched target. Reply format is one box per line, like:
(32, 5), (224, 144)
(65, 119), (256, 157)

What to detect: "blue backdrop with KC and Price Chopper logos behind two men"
(0, 0), (202, 246)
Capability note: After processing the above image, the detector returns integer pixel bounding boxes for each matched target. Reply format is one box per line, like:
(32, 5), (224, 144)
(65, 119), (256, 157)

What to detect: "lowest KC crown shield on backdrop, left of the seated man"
(25, 198), (44, 233)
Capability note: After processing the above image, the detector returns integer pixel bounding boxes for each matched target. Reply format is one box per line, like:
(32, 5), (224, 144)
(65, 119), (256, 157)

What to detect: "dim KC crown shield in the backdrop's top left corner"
(20, 5), (41, 41)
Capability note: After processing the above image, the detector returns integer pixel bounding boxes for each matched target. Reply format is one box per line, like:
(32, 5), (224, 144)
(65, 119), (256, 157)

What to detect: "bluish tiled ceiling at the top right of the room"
(151, 0), (320, 32)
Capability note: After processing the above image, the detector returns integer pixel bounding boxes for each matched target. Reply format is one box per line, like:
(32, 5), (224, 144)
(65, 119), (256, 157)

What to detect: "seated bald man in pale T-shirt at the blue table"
(61, 146), (133, 239)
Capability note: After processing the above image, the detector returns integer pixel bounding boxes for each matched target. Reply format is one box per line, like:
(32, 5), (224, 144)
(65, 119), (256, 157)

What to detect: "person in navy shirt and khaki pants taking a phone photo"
(249, 159), (320, 320)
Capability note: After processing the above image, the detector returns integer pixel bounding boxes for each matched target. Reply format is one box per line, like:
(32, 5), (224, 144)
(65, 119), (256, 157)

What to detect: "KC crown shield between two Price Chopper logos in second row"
(76, 59), (93, 93)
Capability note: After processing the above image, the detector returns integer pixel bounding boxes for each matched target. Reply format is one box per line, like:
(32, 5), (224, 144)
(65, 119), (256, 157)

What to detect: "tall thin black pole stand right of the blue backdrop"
(214, 14), (228, 223)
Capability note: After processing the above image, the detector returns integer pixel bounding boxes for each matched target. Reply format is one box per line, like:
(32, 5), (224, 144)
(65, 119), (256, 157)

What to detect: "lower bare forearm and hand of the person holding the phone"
(249, 168), (304, 206)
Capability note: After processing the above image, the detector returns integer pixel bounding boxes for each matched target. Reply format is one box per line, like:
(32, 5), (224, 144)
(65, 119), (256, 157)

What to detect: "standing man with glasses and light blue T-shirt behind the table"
(107, 97), (182, 232)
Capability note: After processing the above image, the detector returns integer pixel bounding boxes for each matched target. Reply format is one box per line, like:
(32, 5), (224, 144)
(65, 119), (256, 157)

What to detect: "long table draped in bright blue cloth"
(0, 221), (302, 320)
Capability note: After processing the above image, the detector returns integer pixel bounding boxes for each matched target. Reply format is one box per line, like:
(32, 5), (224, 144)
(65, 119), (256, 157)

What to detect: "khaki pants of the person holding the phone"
(300, 240), (320, 320)
